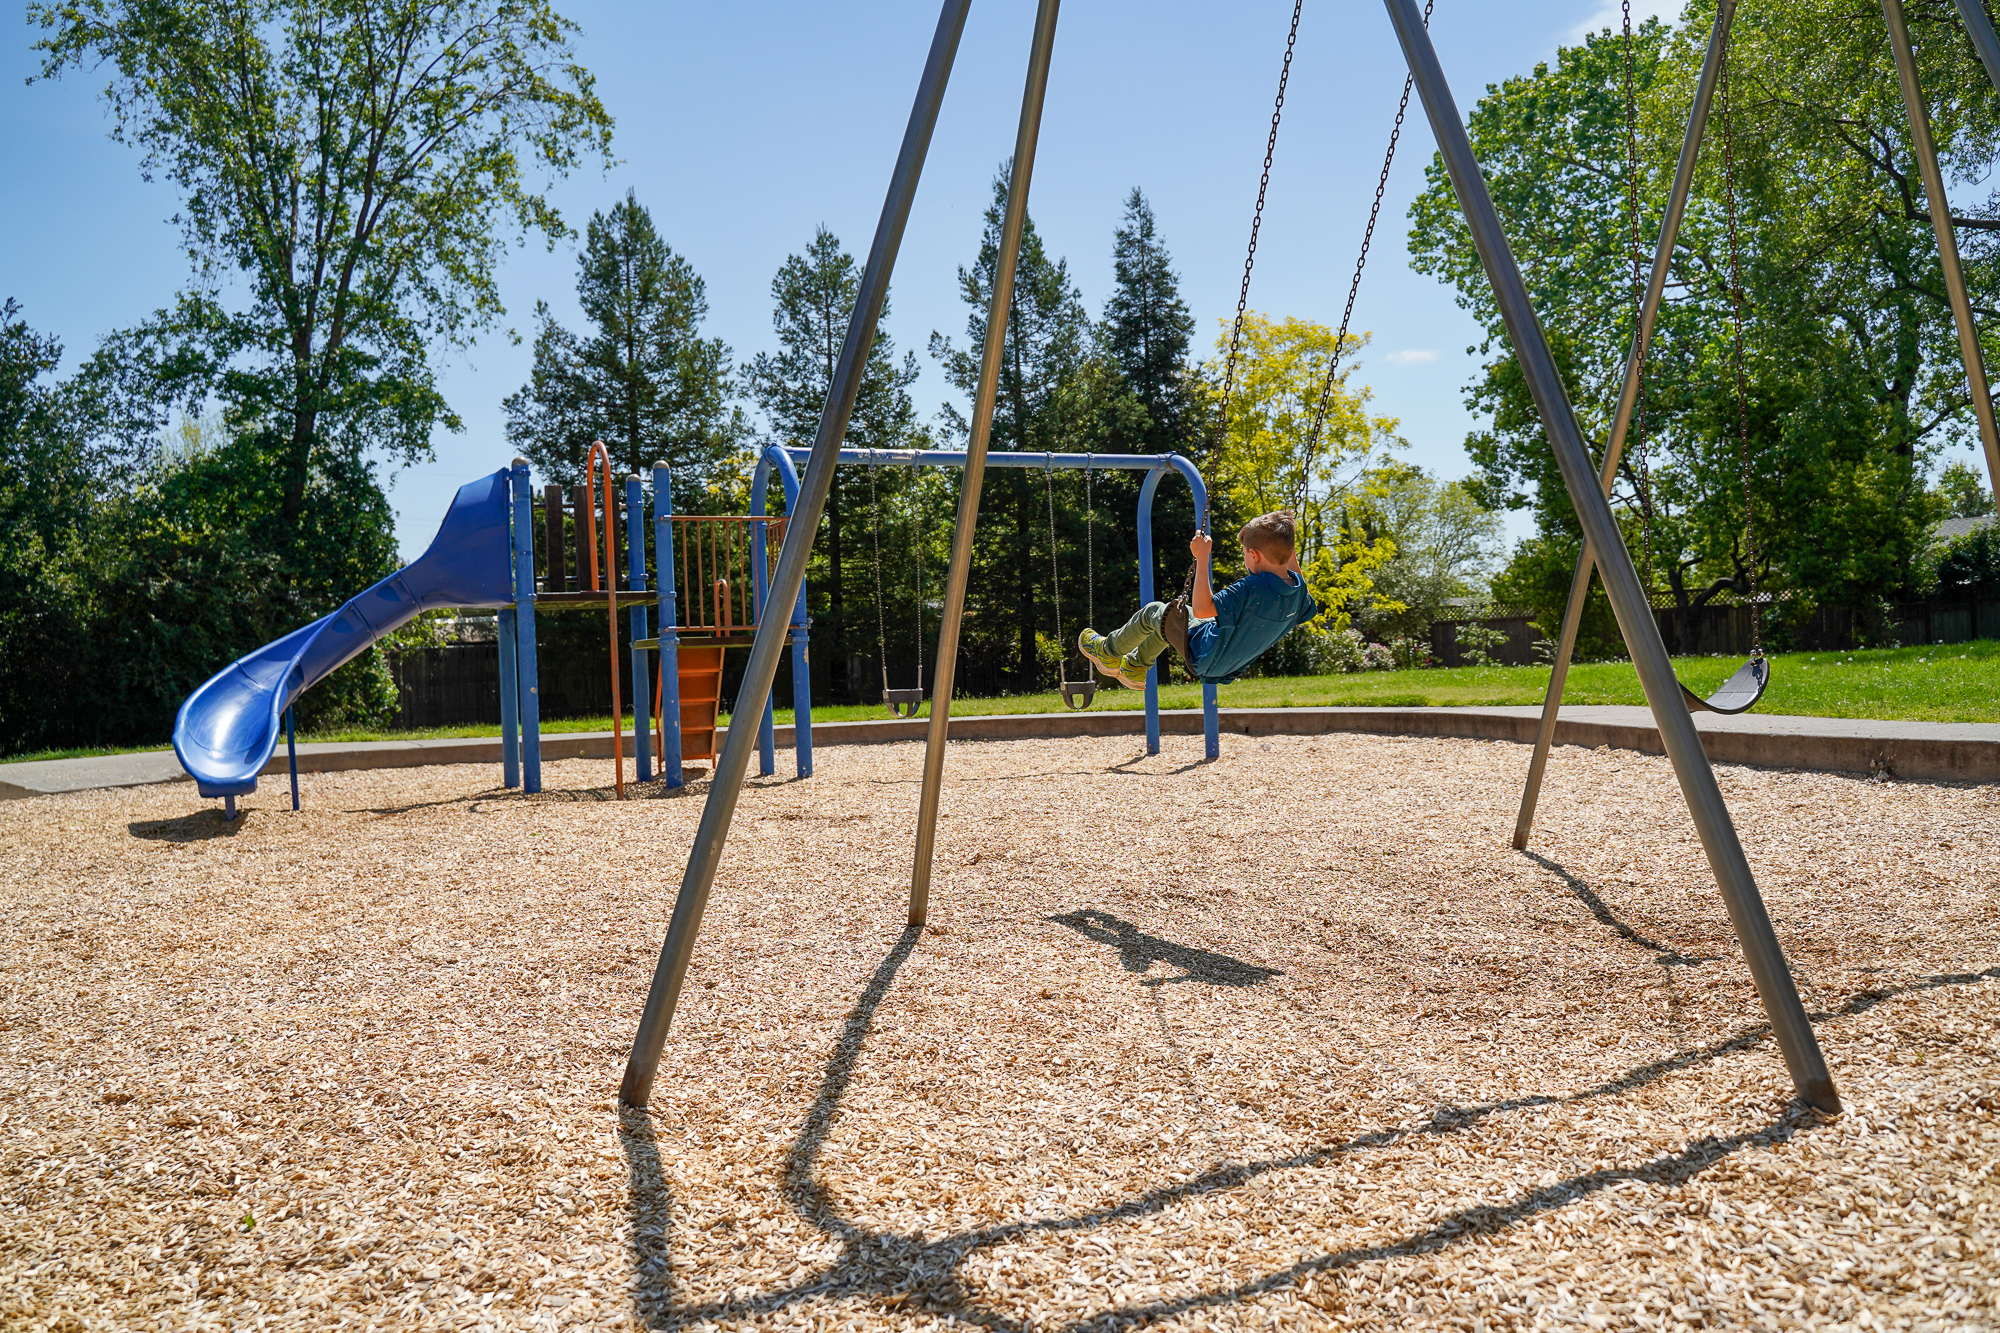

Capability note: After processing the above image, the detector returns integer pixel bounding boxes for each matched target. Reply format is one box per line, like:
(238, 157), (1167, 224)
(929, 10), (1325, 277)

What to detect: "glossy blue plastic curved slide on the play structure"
(174, 470), (514, 797)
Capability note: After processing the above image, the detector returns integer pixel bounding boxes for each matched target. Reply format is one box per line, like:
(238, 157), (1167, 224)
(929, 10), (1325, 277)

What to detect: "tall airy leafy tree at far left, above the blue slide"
(28, 0), (610, 554)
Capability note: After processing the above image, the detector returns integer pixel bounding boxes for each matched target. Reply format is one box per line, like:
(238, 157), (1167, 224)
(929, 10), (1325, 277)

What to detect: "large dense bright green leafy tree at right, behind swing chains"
(1410, 0), (2000, 640)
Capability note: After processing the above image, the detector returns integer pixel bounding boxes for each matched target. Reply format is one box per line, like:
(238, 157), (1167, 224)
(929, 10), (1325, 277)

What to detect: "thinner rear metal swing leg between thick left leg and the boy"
(910, 0), (1062, 925)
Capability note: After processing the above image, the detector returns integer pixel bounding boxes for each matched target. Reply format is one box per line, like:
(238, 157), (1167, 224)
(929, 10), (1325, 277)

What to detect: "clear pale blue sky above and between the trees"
(0, 0), (1678, 554)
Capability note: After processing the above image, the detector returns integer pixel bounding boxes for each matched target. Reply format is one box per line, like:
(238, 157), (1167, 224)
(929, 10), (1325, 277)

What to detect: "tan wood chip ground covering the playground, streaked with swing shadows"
(0, 737), (2000, 1331)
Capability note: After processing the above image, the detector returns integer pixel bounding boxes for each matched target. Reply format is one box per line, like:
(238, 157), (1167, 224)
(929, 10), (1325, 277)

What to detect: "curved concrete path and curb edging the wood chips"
(0, 707), (2000, 801)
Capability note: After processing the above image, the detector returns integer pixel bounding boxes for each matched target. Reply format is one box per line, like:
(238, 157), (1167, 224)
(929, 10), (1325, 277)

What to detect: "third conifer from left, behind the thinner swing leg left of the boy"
(930, 164), (1092, 693)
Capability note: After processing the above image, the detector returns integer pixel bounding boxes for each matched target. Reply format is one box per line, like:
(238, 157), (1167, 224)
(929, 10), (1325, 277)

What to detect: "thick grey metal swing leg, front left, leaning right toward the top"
(618, 0), (972, 1107)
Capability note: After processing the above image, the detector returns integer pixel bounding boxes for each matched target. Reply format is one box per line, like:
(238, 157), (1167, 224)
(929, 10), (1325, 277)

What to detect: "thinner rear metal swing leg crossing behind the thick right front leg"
(1514, 0), (1736, 851)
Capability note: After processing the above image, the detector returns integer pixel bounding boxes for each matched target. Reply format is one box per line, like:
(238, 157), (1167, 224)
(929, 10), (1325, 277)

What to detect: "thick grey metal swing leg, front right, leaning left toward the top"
(1384, 0), (1840, 1113)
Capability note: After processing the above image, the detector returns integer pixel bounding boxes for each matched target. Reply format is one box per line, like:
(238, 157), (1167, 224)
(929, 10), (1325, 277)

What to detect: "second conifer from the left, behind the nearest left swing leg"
(744, 226), (918, 685)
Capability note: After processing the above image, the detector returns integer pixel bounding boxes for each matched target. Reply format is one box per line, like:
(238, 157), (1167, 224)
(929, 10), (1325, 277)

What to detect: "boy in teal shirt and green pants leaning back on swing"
(1076, 508), (1320, 691)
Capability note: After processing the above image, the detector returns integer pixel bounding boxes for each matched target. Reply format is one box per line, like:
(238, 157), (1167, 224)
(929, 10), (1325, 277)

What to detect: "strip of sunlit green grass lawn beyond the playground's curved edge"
(15, 638), (2000, 763)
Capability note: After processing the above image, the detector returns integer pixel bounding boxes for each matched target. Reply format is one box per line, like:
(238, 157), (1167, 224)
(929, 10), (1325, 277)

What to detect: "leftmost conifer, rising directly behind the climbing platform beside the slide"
(502, 192), (744, 496)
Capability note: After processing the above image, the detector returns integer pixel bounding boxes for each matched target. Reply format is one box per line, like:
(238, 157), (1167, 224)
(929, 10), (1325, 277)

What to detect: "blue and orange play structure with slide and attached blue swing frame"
(174, 444), (1220, 817)
